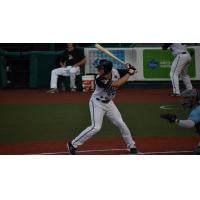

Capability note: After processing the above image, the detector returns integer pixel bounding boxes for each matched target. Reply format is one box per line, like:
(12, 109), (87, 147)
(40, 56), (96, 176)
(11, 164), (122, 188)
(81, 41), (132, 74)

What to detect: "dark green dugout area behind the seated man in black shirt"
(0, 51), (84, 90)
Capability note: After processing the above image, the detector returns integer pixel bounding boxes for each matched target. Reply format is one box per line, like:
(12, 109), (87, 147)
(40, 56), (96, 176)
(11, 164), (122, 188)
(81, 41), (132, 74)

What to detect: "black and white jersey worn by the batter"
(92, 69), (120, 103)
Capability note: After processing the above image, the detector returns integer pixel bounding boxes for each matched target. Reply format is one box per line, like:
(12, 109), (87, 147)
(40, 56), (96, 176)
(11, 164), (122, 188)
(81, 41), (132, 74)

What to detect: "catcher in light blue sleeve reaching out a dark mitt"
(160, 89), (200, 155)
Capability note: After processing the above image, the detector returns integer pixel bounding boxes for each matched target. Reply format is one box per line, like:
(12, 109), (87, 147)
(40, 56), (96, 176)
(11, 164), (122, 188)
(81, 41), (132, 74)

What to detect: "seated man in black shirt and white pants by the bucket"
(47, 43), (86, 93)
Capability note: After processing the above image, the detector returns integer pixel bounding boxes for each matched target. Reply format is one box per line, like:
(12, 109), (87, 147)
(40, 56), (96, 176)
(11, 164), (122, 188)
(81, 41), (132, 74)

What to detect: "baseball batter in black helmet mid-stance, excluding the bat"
(67, 59), (138, 155)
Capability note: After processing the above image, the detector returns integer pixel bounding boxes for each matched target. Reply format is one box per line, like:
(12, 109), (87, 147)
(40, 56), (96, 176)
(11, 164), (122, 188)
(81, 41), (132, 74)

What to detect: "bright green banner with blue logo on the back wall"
(143, 49), (196, 79)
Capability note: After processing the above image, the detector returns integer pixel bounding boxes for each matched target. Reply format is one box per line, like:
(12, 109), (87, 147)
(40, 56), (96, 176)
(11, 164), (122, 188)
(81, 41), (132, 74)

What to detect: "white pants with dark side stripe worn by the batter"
(72, 98), (135, 149)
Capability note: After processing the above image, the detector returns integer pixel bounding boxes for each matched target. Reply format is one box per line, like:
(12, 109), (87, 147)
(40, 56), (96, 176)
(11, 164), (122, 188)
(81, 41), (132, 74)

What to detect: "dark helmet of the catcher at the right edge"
(181, 89), (200, 108)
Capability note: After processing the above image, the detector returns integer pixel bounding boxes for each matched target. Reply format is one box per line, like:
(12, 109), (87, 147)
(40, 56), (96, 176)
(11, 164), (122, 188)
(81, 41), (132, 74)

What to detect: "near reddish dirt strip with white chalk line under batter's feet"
(0, 137), (197, 155)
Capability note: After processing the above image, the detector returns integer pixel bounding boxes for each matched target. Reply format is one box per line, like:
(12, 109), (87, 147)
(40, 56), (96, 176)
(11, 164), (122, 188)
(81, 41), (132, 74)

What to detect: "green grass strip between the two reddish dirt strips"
(0, 103), (195, 144)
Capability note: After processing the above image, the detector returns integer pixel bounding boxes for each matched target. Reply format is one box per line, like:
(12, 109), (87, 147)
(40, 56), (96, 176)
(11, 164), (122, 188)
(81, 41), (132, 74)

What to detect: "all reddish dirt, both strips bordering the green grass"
(0, 89), (198, 155)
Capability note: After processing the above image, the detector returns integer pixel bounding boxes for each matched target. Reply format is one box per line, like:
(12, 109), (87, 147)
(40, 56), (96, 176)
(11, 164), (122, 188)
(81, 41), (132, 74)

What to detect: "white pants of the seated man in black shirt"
(50, 66), (80, 88)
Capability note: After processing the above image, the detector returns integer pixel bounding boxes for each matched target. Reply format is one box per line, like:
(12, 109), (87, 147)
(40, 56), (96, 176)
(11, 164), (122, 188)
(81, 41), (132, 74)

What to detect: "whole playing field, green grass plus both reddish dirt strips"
(0, 88), (198, 155)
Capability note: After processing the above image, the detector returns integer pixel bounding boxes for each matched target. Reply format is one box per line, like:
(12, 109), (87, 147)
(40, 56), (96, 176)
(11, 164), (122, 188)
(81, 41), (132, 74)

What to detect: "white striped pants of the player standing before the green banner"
(170, 53), (192, 94)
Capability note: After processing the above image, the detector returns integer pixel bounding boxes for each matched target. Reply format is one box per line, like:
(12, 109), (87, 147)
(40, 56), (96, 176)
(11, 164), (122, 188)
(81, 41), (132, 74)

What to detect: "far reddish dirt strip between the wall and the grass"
(0, 89), (177, 104)
